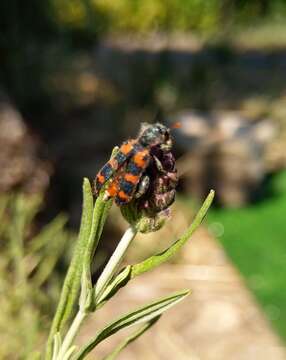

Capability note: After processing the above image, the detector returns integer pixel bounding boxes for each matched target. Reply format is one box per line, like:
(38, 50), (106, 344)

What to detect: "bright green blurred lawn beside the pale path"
(208, 171), (286, 341)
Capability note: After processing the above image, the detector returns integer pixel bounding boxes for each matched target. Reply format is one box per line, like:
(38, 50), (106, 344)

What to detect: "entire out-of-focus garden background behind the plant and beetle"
(0, 0), (286, 360)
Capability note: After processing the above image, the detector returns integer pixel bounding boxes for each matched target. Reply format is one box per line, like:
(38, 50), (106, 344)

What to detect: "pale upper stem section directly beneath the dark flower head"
(95, 227), (137, 300)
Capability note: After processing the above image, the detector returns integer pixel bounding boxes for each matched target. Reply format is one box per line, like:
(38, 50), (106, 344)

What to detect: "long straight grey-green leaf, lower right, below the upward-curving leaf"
(74, 290), (190, 360)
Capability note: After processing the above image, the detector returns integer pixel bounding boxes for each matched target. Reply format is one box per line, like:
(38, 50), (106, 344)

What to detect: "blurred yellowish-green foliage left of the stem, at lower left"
(0, 194), (71, 359)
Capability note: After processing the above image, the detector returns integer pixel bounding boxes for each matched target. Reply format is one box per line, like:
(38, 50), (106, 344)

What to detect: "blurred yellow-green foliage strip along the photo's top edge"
(52, 0), (286, 33)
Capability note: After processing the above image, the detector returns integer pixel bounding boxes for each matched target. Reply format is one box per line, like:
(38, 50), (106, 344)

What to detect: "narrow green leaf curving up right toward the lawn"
(131, 190), (215, 278)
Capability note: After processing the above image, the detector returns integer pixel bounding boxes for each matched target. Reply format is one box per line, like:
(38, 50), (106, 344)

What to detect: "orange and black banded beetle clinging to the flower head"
(94, 123), (173, 206)
